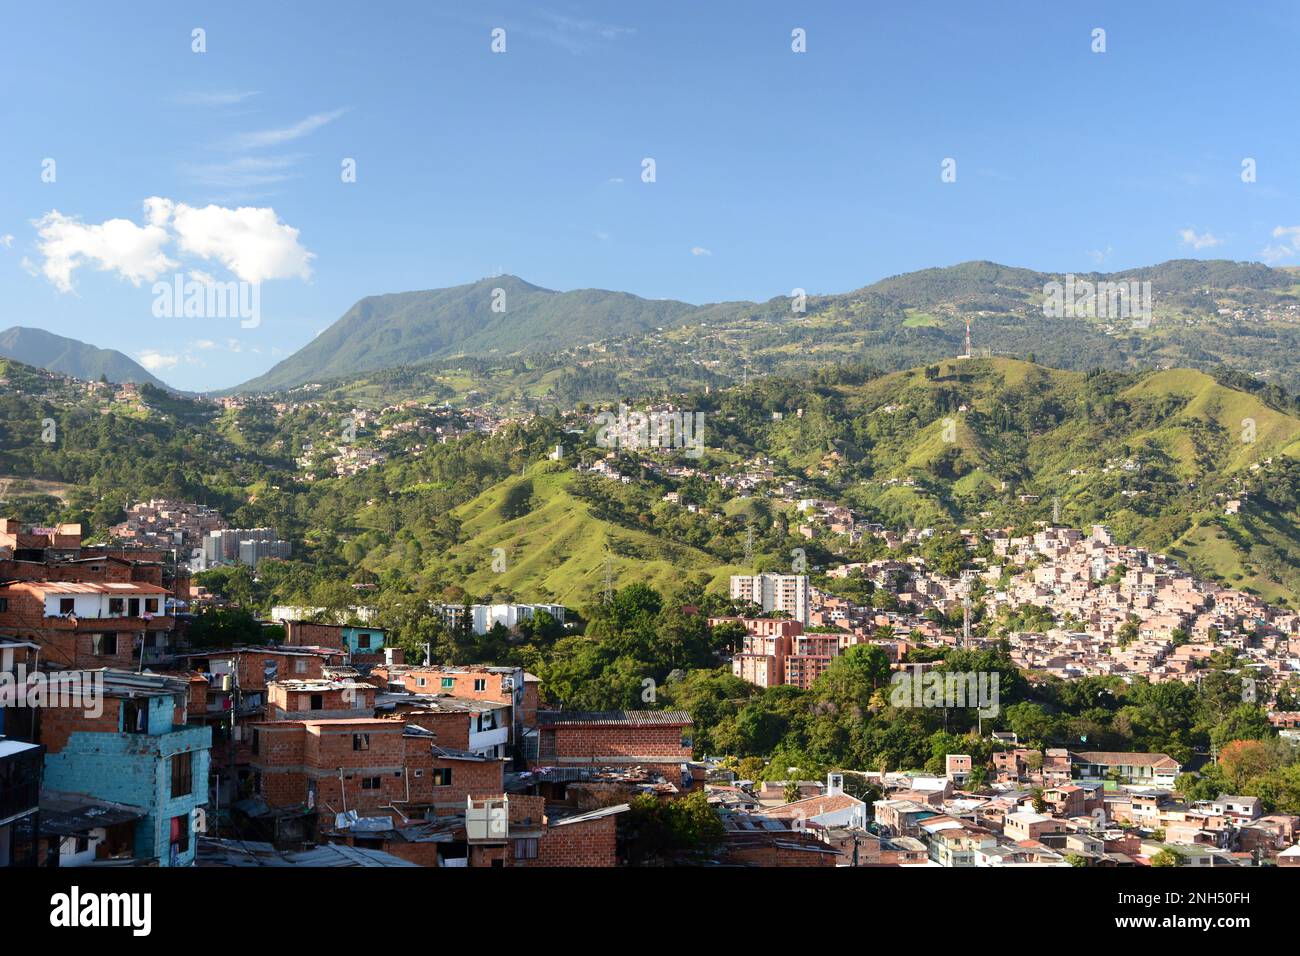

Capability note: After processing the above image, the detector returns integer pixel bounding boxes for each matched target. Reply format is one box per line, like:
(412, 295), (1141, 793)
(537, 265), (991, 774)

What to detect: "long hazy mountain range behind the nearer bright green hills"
(230, 260), (1300, 402)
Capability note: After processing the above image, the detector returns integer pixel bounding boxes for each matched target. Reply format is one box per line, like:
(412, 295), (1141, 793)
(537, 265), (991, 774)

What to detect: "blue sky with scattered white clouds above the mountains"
(0, 0), (1300, 389)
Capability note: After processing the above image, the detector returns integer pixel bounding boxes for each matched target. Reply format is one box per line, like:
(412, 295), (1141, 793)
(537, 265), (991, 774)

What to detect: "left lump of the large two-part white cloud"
(33, 208), (176, 293)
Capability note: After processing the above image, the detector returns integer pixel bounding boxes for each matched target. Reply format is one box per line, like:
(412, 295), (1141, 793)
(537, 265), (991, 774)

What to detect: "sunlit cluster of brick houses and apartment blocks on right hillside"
(732, 525), (1300, 697)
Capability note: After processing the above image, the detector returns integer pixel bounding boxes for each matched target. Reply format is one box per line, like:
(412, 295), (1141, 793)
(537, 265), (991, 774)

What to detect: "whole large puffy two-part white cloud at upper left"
(23, 196), (315, 293)
